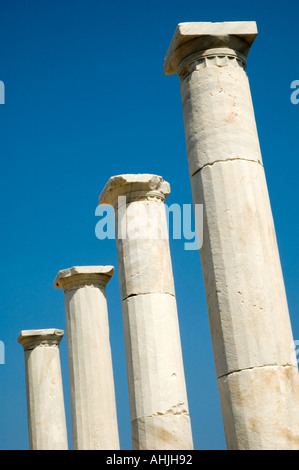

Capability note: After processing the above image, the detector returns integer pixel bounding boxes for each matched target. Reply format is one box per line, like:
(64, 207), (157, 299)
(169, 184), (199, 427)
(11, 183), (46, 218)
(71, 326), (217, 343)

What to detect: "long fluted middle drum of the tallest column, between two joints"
(191, 160), (296, 377)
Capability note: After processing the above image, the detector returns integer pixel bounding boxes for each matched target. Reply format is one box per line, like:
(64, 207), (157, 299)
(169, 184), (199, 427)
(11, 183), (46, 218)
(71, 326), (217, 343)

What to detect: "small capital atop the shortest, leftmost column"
(18, 328), (64, 351)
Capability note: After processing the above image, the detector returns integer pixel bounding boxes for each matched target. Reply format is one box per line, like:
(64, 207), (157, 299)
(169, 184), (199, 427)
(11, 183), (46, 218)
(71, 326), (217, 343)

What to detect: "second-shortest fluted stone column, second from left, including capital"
(54, 266), (119, 450)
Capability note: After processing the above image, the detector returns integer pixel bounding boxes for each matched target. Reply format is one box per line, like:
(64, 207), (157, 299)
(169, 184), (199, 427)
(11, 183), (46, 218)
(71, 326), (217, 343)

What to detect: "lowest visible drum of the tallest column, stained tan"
(218, 366), (299, 450)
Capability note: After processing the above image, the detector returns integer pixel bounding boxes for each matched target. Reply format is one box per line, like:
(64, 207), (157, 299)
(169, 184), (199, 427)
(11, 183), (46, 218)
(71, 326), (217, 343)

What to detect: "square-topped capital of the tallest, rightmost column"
(164, 21), (257, 75)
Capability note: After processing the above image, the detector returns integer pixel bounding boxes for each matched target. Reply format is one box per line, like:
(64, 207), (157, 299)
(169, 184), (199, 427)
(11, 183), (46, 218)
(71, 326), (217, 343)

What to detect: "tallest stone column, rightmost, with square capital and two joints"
(164, 22), (299, 449)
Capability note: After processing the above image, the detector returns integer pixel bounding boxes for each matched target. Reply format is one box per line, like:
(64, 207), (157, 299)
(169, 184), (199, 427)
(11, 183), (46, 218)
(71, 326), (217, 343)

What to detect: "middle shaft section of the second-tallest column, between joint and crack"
(122, 294), (188, 420)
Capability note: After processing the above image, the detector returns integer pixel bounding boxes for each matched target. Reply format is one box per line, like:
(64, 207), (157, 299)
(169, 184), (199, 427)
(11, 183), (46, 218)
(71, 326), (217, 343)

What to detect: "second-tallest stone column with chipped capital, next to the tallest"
(99, 174), (193, 450)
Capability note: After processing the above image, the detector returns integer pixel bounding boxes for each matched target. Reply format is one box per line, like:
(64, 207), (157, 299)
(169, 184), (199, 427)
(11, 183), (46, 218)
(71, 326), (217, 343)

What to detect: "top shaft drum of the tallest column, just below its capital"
(181, 65), (263, 176)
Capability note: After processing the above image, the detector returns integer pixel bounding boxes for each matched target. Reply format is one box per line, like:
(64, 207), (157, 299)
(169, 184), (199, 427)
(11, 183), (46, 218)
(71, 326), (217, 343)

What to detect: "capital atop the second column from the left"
(54, 266), (114, 290)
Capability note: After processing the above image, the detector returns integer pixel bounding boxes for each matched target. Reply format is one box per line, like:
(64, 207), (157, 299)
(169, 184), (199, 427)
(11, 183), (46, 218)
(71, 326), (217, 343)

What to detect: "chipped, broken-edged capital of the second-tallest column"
(99, 174), (170, 207)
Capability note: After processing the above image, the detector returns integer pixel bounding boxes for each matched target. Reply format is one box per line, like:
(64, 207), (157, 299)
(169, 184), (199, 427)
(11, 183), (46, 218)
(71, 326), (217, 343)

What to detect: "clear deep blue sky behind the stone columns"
(0, 0), (299, 449)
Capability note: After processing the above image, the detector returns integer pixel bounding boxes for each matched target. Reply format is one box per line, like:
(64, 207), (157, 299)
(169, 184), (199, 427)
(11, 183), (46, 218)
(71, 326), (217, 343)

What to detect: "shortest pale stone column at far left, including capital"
(18, 329), (68, 450)
